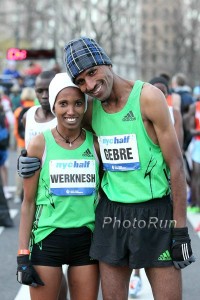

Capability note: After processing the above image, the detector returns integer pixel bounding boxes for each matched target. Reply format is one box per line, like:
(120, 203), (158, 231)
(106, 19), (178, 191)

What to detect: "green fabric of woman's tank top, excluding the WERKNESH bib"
(32, 130), (99, 243)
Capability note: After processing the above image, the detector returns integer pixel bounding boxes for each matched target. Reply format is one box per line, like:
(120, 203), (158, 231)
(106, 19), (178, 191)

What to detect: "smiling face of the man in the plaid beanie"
(74, 65), (113, 101)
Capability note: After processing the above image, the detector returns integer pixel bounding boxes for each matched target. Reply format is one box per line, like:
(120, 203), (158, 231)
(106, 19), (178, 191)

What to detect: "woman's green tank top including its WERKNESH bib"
(31, 130), (99, 244)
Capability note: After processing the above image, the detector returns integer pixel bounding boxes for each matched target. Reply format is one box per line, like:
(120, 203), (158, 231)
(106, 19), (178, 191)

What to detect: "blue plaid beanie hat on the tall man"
(64, 37), (112, 81)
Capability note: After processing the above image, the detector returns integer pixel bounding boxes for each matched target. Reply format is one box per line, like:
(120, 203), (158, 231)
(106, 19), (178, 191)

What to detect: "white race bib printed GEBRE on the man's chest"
(98, 134), (140, 172)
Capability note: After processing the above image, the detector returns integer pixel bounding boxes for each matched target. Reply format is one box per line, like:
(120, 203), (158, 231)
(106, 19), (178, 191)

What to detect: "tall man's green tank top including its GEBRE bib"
(92, 80), (170, 203)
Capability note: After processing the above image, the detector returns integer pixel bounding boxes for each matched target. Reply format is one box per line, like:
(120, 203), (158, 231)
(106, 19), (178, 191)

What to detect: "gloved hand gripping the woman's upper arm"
(17, 149), (41, 178)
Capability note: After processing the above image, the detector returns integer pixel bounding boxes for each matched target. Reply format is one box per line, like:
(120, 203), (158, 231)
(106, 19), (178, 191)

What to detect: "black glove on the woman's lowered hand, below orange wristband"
(16, 254), (44, 287)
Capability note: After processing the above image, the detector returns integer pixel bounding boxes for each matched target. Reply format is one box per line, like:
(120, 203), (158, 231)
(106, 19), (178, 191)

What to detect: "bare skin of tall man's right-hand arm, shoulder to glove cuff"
(141, 85), (187, 227)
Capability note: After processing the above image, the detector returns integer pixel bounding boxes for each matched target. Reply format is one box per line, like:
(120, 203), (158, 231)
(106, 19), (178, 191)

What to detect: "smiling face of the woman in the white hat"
(54, 87), (85, 129)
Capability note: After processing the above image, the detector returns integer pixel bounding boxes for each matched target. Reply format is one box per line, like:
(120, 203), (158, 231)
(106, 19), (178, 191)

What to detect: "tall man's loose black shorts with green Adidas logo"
(90, 196), (173, 269)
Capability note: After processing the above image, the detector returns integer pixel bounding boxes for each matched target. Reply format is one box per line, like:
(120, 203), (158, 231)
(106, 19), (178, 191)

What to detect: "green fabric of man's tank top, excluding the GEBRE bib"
(92, 80), (170, 203)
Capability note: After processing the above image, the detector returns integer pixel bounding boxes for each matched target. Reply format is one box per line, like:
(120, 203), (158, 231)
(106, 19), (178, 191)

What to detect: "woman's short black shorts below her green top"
(31, 227), (98, 267)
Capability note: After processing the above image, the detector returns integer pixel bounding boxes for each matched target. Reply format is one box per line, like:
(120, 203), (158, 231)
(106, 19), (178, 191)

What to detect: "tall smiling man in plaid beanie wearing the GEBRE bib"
(19, 38), (195, 300)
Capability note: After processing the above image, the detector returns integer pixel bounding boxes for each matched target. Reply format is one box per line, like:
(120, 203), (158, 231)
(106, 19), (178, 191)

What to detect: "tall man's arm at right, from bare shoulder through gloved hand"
(141, 86), (195, 269)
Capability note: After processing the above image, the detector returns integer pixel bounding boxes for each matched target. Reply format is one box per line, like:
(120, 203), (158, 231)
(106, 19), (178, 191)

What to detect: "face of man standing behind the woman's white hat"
(35, 77), (52, 111)
